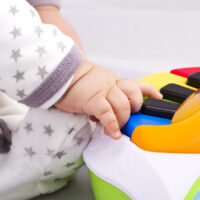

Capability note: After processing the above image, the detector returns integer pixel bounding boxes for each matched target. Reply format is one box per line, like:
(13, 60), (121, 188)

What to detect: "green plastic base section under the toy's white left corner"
(89, 170), (131, 200)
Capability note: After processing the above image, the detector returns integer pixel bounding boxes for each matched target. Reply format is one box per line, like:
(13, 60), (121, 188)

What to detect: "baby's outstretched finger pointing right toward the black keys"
(138, 82), (162, 99)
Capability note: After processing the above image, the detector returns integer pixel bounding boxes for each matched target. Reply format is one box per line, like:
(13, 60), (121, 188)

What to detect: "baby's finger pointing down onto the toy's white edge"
(86, 96), (121, 139)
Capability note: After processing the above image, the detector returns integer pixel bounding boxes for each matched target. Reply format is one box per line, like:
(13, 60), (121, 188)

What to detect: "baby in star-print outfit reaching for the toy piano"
(0, 0), (161, 200)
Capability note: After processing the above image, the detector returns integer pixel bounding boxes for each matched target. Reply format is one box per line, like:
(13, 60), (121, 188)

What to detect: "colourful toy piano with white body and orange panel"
(84, 67), (200, 200)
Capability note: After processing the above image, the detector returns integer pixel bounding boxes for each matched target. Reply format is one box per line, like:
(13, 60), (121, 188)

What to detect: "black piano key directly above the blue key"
(141, 98), (180, 119)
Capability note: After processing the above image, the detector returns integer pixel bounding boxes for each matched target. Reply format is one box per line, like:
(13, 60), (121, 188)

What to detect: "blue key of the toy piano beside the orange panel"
(121, 113), (171, 138)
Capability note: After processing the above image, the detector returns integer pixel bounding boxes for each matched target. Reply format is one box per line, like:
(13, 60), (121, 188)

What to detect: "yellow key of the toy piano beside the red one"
(140, 72), (196, 91)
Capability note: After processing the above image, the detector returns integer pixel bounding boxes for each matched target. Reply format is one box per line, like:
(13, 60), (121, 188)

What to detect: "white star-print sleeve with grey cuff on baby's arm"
(0, 0), (82, 109)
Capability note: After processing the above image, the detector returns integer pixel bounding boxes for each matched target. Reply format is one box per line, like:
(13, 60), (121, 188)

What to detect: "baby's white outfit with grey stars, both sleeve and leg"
(0, 0), (92, 200)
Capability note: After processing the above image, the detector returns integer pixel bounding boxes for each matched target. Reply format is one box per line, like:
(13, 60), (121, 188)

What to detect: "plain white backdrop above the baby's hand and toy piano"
(62, 0), (200, 79)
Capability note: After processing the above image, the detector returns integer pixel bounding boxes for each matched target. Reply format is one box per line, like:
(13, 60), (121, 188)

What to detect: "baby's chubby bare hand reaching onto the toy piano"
(55, 61), (161, 139)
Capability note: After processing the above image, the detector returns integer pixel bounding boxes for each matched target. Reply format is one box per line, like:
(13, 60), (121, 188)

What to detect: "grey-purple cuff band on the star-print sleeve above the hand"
(19, 45), (82, 107)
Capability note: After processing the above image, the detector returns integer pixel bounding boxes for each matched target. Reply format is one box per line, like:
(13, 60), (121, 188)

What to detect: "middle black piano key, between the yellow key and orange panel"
(160, 83), (195, 103)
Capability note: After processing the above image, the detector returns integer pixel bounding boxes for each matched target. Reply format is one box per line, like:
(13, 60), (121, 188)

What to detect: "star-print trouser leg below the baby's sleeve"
(0, 92), (92, 200)
